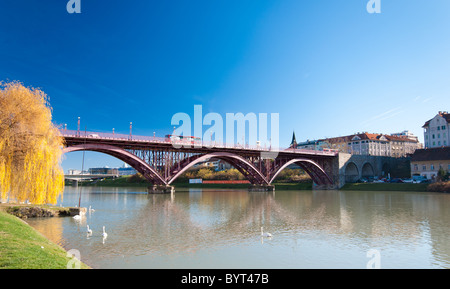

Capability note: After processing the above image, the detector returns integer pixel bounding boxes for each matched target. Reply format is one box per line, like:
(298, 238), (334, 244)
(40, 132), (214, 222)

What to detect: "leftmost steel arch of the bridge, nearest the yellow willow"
(63, 144), (167, 185)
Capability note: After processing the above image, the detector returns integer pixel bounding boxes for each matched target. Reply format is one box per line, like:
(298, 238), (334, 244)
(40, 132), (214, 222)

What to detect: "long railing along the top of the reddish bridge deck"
(60, 129), (336, 156)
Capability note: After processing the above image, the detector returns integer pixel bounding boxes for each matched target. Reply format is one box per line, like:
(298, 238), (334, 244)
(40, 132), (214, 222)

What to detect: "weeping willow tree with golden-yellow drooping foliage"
(0, 82), (64, 204)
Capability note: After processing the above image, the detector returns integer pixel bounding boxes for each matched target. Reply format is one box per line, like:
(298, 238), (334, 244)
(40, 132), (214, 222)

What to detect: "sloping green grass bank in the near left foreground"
(0, 211), (89, 269)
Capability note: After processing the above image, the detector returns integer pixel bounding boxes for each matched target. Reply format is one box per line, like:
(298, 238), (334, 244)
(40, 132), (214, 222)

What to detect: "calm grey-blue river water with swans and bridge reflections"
(28, 187), (450, 269)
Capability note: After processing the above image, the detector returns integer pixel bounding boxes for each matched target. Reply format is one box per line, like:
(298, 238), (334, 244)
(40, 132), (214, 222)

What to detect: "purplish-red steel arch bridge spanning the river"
(61, 129), (337, 192)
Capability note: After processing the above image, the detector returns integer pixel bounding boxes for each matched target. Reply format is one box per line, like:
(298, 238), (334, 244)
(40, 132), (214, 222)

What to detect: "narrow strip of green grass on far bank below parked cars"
(341, 183), (428, 192)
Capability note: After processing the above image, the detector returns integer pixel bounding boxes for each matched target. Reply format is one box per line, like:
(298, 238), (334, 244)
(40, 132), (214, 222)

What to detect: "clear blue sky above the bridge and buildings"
(0, 0), (450, 170)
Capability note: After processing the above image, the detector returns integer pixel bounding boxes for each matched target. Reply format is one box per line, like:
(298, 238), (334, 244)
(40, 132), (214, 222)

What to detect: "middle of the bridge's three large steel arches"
(166, 152), (269, 185)
